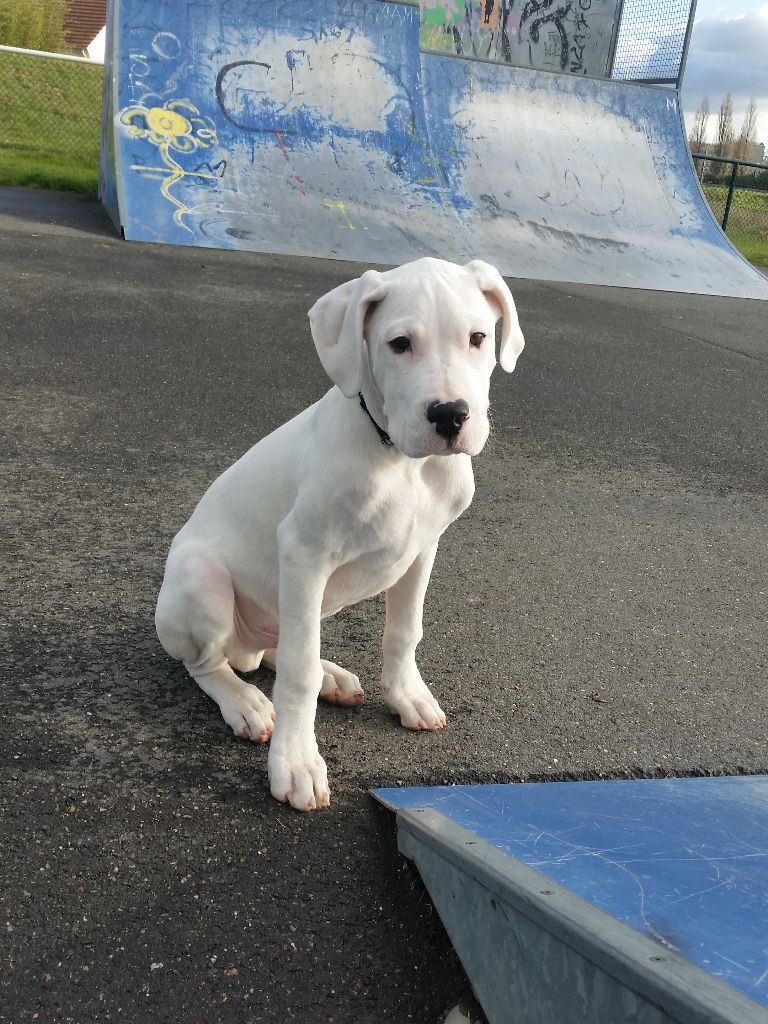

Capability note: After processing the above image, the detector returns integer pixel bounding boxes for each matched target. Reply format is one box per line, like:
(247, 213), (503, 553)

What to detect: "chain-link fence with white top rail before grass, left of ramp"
(0, 46), (103, 190)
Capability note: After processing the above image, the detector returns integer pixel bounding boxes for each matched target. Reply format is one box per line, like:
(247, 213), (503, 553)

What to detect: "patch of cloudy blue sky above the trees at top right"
(682, 0), (768, 154)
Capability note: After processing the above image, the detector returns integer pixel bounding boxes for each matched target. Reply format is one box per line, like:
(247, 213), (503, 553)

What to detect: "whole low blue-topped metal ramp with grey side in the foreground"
(374, 776), (768, 1024)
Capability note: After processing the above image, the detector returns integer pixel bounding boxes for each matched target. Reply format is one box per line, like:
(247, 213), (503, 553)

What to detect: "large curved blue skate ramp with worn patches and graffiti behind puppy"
(101, 0), (768, 298)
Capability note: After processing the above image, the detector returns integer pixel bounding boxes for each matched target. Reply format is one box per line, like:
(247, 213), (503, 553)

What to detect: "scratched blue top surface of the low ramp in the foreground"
(374, 775), (768, 1006)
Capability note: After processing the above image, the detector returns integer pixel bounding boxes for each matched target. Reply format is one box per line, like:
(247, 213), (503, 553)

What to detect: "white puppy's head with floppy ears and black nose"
(309, 258), (524, 459)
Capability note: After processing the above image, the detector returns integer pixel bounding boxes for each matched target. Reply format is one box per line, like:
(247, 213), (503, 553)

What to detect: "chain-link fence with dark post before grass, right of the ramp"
(693, 153), (768, 242)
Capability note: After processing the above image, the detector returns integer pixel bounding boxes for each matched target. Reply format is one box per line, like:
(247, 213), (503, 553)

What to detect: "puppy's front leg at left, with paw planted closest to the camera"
(267, 521), (331, 811)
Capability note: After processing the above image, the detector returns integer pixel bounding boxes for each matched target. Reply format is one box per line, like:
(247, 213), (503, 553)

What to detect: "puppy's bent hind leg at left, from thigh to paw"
(155, 546), (274, 742)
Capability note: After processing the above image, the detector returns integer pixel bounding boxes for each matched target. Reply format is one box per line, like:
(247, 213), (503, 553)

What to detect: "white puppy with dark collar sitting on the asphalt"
(156, 259), (524, 810)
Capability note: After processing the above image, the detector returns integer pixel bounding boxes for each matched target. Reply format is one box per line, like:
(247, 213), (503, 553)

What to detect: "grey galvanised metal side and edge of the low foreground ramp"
(397, 802), (768, 1024)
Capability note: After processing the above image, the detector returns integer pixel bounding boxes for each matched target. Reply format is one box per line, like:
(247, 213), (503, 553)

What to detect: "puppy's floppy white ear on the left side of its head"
(309, 270), (387, 398)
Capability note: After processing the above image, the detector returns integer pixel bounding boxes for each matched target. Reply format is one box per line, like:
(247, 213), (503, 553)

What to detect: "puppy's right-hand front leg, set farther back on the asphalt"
(381, 543), (445, 729)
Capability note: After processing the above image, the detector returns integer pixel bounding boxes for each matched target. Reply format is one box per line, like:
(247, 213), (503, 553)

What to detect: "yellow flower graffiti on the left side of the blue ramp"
(120, 99), (218, 231)
